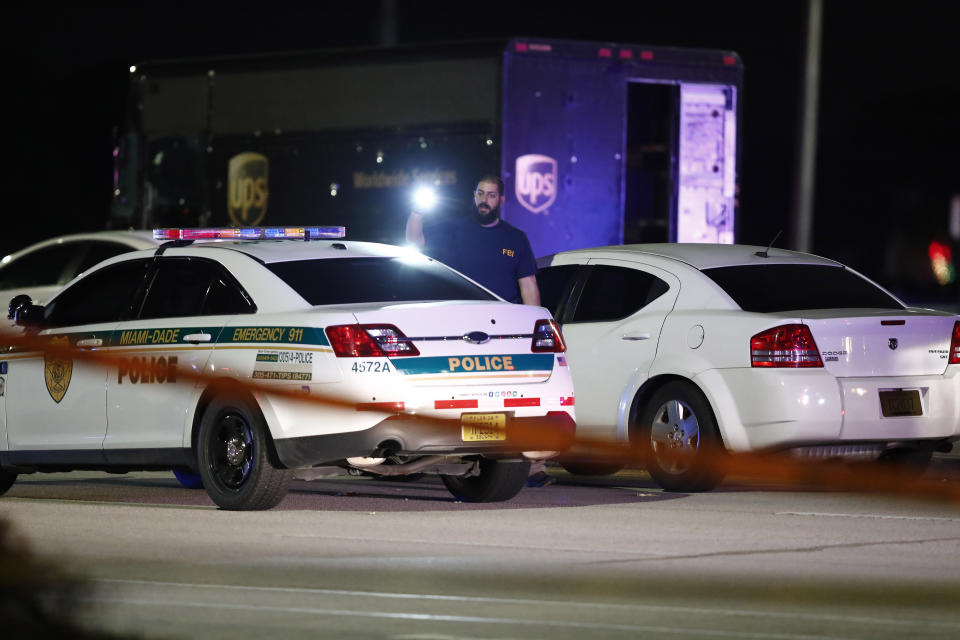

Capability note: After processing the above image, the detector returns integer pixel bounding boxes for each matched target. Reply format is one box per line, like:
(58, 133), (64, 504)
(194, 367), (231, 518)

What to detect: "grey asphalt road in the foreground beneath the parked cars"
(0, 459), (960, 640)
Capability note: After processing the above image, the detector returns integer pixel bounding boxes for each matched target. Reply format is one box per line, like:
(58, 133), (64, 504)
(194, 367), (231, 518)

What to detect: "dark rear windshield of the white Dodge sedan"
(703, 264), (904, 313)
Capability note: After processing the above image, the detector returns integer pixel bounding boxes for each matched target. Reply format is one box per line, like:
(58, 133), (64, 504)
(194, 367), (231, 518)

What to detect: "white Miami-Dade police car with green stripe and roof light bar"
(0, 227), (575, 510)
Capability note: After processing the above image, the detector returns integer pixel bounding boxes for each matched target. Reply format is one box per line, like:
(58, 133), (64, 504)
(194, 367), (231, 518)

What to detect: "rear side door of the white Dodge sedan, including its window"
(563, 258), (680, 441)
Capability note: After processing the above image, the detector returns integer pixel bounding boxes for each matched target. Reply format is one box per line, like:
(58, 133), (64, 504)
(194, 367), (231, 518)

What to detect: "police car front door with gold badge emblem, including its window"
(6, 259), (150, 452)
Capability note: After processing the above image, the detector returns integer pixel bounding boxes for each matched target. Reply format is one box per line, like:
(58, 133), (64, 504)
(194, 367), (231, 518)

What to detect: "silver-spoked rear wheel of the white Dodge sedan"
(637, 382), (725, 492)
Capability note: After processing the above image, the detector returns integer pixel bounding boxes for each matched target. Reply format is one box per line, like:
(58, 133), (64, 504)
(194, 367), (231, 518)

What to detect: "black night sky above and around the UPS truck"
(7, 0), (960, 304)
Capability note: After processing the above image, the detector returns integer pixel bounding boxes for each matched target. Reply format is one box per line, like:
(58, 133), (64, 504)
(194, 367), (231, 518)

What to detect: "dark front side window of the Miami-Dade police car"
(44, 259), (150, 327)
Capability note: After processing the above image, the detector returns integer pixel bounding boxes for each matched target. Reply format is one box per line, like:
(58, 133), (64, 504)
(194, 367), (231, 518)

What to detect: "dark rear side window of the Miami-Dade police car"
(139, 258), (251, 319)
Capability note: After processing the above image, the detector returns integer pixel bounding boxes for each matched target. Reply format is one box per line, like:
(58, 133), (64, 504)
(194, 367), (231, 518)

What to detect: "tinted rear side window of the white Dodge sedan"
(573, 265), (670, 322)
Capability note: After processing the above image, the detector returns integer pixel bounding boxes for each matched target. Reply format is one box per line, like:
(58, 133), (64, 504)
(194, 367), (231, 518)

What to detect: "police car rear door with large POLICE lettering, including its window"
(104, 256), (256, 452)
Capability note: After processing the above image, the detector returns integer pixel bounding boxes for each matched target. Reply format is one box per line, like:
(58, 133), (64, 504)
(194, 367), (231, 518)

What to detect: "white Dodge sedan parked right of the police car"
(537, 244), (960, 491)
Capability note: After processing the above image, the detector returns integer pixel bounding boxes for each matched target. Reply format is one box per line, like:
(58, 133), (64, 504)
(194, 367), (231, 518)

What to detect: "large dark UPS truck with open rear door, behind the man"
(110, 38), (743, 256)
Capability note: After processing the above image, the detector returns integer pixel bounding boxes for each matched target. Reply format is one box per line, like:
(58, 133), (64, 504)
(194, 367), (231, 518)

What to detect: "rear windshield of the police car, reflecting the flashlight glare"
(266, 258), (497, 305)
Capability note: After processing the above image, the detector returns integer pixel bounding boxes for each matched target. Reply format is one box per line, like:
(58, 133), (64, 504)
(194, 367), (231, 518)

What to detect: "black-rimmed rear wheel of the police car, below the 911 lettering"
(197, 394), (293, 511)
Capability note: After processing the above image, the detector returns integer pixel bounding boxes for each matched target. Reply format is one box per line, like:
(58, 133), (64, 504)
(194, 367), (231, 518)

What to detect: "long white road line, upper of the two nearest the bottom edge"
(94, 578), (960, 637)
